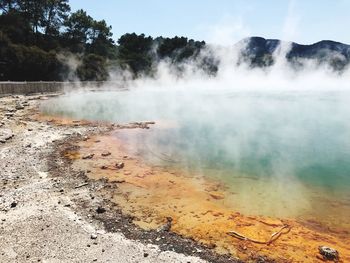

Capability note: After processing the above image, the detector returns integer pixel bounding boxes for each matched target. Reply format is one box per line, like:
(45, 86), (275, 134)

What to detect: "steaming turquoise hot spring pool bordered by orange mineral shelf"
(42, 87), (350, 229)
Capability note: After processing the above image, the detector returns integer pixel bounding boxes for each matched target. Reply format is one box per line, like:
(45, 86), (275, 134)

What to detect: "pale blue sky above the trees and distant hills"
(70, 0), (350, 44)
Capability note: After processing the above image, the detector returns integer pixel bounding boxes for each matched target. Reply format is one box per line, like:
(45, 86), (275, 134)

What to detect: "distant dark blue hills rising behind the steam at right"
(237, 37), (350, 70)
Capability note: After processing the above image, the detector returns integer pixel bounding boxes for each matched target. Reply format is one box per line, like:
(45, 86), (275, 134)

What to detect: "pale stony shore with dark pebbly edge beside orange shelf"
(0, 96), (241, 262)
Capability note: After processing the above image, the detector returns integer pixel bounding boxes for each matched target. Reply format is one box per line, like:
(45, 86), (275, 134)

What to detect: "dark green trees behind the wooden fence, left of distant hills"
(0, 0), (211, 81)
